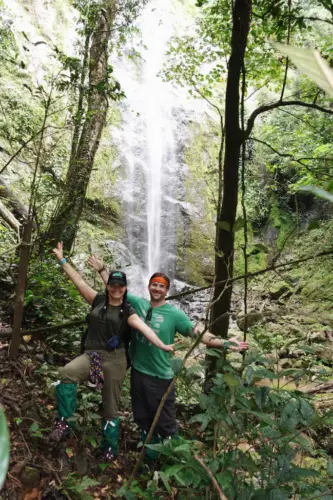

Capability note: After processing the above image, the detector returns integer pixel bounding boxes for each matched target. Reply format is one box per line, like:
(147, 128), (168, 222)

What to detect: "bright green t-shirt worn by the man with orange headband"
(127, 293), (193, 379)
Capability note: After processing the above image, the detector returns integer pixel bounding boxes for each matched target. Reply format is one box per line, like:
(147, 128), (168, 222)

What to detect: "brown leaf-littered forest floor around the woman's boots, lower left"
(0, 341), (198, 500)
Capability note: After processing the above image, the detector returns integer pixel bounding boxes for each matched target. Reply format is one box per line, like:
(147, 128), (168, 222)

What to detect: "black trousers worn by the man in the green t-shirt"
(131, 367), (177, 437)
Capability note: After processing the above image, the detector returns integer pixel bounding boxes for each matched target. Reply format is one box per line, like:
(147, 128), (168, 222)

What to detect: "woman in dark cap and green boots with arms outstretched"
(51, 242), (173, 460)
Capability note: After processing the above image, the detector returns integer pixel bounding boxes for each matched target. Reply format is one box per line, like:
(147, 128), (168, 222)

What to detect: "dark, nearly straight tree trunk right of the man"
(211, 0), (252, 337)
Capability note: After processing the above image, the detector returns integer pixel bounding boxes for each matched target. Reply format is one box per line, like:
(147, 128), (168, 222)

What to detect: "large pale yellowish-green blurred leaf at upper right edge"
(274, 43), (333, 97)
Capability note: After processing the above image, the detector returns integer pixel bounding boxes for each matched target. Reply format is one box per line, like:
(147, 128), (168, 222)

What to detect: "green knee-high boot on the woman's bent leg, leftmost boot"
(50, 382), (77, 443)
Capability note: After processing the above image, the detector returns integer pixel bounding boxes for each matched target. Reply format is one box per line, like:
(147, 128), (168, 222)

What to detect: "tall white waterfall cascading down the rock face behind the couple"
(108, 0), (203, 295)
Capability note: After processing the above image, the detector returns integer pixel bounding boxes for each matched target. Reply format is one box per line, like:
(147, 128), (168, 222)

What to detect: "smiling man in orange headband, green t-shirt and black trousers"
(88, 256), (248, 458)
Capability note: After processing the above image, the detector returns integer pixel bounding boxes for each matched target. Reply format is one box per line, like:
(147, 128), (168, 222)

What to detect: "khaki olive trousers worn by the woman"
(59, 349), (127, 420)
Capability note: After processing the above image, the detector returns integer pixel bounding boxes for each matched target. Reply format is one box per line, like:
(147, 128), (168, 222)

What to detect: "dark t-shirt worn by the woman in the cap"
(84, 294), (136, 350)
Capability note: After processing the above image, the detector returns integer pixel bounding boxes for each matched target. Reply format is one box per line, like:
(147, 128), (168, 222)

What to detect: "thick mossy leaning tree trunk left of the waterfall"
(47, 0), (116, 250)
